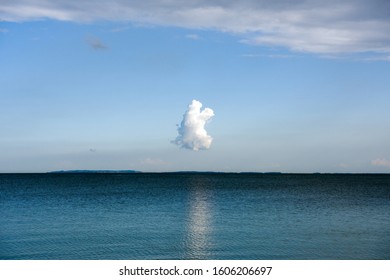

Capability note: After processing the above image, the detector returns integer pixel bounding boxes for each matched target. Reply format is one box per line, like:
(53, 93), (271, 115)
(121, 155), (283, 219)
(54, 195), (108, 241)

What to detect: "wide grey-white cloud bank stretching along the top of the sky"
(0, 0), (390, 57)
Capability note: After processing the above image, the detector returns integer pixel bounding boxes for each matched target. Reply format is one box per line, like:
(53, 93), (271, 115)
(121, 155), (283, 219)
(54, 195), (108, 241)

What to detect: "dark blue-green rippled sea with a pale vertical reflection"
(0, 174), (390, 259)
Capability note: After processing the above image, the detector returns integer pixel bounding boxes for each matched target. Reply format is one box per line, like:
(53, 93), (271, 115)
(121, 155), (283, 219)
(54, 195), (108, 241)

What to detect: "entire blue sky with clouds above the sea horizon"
(0, 0), (390, 173)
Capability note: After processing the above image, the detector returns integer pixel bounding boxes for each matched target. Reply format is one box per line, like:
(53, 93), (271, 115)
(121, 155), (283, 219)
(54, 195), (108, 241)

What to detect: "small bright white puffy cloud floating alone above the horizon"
(173, 100), (214, 151)
